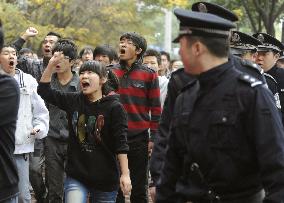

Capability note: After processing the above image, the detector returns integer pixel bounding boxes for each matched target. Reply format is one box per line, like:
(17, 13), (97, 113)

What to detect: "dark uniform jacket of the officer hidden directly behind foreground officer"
(150, 54), (268, 185)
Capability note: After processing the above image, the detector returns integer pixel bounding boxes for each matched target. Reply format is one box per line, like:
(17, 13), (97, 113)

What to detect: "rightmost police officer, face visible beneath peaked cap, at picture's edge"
(253, 33), (284, 121)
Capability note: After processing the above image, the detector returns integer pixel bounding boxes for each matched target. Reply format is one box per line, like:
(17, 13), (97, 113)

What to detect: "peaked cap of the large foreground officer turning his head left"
(173, 8), (235, 43)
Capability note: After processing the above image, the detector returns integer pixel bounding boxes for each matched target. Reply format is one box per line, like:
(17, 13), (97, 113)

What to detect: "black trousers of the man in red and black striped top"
(116, 140), (148, 203)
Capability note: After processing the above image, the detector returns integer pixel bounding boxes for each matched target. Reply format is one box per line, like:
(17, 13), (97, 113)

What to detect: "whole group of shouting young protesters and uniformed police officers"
(0, 2), (284, 203)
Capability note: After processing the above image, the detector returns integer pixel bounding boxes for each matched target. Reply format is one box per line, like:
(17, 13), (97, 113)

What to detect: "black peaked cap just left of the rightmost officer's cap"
(230, 31), (262, 55)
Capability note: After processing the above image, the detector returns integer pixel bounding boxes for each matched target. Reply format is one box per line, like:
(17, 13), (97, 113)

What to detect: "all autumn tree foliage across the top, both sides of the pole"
(0, 0), (284, 55)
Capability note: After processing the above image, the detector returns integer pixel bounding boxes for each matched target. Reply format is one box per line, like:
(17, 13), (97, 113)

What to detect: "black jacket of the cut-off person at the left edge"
(0, 74), (20, 202)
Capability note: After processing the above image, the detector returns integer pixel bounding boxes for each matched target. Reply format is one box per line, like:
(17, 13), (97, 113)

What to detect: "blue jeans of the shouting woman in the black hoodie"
(64, 177), (117, 203)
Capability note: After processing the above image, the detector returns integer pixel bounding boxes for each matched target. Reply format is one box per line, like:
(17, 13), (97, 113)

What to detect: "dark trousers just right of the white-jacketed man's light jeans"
(29, 140), (47, 203)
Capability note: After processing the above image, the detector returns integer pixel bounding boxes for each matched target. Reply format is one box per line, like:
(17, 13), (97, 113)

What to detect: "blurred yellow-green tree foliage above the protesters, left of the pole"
(0, 0), (162, 54)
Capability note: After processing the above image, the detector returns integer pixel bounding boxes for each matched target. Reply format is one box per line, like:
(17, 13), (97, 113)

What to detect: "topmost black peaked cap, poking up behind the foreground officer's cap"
(191, 1), (239, 22)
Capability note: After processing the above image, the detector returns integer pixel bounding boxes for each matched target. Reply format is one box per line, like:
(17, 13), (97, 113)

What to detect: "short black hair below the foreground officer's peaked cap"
(187, 35), (230, 58)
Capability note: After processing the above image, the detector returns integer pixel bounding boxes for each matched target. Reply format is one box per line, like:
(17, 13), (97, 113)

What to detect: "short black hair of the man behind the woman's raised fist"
(52, 39), (77, 60)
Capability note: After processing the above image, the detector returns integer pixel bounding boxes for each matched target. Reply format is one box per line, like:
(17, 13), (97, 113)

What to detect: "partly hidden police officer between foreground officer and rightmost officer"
(230, 31), (281, 110)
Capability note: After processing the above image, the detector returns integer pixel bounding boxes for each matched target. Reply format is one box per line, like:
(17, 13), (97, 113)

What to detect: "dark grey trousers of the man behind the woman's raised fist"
(44, 136), (67, 203)
